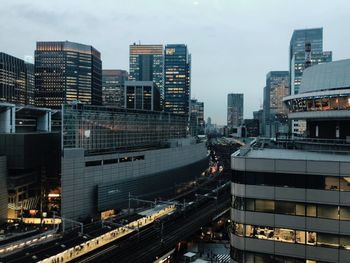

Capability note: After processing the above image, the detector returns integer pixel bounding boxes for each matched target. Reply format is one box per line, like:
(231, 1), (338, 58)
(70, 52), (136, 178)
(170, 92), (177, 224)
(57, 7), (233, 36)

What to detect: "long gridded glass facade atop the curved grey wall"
(62, 104), (187, 154)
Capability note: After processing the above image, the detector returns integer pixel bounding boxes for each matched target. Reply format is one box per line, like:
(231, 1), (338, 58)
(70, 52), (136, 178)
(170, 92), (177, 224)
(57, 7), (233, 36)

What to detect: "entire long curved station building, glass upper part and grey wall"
(61, 105), (208, 219)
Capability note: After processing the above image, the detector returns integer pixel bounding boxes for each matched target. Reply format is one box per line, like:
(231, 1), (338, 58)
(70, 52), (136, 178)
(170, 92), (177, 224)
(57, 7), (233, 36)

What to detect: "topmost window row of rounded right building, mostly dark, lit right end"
(232, 170), (350, 191)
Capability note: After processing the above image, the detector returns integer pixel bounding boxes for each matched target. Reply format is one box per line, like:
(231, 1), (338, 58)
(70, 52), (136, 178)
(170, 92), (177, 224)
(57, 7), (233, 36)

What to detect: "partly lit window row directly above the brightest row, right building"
(232, 197), (350, 220)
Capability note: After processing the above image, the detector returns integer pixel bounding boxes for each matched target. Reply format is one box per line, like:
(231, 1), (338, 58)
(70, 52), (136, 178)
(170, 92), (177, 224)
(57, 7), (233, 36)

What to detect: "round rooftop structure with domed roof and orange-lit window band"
(284, 59), (350, 140)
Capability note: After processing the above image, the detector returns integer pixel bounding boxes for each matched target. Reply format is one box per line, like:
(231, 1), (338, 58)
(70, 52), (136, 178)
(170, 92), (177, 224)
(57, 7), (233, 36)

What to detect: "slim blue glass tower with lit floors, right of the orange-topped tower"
(164, 44), (191, 115)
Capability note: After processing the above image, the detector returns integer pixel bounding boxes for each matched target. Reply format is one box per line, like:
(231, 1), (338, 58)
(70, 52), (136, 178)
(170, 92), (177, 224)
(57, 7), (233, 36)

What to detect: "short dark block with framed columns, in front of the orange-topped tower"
(124, 81), (160, 111)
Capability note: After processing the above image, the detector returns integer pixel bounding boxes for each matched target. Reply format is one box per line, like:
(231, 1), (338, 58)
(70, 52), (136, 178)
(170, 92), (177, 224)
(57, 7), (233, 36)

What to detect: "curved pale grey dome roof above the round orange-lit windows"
(299, 59), (350, 94)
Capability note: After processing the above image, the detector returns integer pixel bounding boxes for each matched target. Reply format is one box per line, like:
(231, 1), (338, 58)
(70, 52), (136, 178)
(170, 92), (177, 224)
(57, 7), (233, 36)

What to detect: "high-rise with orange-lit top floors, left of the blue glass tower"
(129, 43), (164, 107)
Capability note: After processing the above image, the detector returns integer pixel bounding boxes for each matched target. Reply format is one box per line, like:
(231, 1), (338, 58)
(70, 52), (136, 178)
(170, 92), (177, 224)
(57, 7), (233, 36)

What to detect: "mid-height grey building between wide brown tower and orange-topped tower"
(102, 69), (128, 108)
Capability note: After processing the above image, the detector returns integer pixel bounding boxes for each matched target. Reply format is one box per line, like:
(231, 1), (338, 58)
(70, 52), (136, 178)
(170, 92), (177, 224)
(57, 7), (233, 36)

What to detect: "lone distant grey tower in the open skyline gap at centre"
(227, 93), (243, 128)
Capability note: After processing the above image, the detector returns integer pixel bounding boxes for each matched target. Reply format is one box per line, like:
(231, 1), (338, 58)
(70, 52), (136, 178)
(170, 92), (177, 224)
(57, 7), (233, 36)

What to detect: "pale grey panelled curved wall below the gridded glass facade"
(61, 143), (207, 219)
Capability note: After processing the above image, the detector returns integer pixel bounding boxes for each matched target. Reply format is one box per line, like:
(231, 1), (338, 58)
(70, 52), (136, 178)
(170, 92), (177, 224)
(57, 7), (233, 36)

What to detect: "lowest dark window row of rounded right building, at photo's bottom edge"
(230, 247), (322, 263)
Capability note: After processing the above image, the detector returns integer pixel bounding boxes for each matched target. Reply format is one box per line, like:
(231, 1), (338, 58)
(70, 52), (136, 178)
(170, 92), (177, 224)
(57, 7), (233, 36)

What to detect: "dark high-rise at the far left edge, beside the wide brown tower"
(0, 52), (34, 105)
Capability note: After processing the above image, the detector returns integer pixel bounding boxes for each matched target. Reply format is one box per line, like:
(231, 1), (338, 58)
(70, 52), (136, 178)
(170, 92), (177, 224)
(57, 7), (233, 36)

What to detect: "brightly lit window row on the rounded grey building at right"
(232, 222), (350, 250)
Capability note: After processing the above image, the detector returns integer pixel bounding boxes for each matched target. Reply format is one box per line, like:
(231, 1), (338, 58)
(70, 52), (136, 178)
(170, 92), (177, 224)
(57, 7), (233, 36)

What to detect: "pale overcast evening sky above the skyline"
(0, 0), (350, 124)
